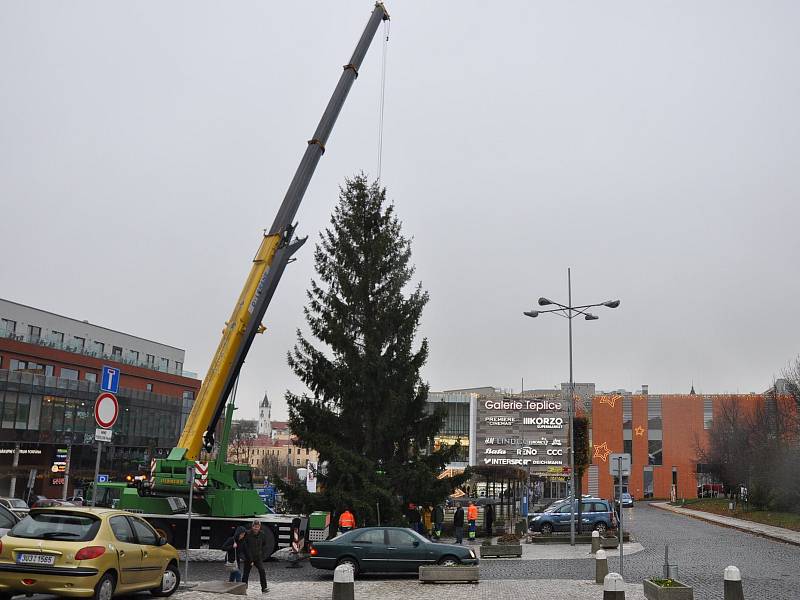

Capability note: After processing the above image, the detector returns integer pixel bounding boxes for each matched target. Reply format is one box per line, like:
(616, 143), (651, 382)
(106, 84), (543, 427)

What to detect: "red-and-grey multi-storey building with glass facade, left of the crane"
(0, 299), (200, 498)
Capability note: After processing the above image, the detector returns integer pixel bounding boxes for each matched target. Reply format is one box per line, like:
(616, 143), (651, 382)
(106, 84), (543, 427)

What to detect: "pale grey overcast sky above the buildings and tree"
(0, 0), (800, 417)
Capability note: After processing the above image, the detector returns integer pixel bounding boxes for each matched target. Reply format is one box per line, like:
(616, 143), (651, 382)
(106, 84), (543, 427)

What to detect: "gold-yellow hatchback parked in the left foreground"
(0, 507), (181, 600)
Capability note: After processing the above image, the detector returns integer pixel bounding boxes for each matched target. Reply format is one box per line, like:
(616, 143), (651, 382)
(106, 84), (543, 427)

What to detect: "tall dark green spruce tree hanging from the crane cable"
(283, 174), (463, 523)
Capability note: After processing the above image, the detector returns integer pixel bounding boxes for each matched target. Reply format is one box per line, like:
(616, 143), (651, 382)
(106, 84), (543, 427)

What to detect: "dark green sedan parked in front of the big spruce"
(311, 527), (478, 574)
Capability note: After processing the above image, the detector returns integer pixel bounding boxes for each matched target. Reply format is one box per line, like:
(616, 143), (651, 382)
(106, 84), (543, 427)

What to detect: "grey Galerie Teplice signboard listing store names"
(475, 394), (569, 477)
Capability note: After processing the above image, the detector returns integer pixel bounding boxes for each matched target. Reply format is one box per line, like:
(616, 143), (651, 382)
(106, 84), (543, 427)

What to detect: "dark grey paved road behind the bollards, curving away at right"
(189, 503), (800, 600)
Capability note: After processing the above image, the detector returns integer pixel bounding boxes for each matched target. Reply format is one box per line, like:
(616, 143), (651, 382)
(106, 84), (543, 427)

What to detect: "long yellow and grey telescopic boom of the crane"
(169, 2), (389, 460)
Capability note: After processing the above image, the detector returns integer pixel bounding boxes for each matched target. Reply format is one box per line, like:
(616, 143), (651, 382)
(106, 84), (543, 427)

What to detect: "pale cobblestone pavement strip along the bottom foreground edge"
(173, 578), (644, 600)
